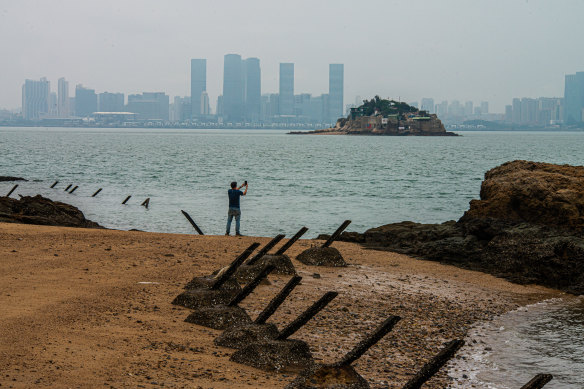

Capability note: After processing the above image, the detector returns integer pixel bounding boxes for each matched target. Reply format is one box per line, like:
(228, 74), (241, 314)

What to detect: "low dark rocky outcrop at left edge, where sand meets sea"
(0, 195), (103, 228)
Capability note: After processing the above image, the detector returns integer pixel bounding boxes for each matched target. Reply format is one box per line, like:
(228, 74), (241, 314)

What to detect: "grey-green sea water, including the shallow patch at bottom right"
(0, 127), (584, 388)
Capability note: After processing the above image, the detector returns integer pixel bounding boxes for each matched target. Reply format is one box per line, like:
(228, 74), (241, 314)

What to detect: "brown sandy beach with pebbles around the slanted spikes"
(0, 223), (558, 388)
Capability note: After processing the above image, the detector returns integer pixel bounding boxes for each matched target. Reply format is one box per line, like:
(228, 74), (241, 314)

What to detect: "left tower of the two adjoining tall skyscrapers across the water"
(223, 54), (244, 122)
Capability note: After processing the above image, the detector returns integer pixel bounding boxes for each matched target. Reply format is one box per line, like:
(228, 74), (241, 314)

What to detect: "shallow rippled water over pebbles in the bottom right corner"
(450, 297), (584, 389)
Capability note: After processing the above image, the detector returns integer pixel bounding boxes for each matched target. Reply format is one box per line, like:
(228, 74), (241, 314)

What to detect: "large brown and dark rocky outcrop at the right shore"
(340, 161), (584, 294)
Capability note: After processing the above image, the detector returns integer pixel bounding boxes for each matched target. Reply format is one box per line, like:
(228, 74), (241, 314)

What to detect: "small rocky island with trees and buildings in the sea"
(290, 96), (457, 136)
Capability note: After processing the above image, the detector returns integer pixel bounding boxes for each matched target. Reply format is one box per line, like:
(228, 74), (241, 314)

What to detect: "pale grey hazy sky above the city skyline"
(0, 0), (584, 112)
